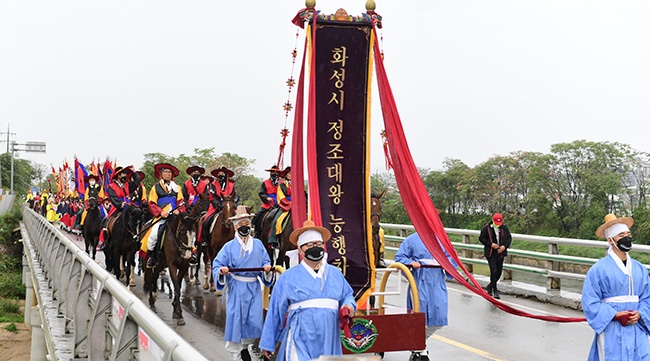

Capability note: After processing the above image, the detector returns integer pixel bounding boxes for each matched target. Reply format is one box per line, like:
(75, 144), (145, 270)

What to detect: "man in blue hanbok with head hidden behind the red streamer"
(395, 233), (456, 361)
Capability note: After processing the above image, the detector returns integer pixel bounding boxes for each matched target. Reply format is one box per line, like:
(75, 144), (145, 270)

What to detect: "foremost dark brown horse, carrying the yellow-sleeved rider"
(143, 213), (196, 326)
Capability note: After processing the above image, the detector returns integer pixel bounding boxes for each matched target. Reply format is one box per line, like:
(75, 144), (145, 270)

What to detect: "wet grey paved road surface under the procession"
(64, 231), (593, 361)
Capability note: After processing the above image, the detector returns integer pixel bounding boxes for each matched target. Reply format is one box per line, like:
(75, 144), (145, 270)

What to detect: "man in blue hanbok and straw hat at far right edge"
(582, 214), (650, 361)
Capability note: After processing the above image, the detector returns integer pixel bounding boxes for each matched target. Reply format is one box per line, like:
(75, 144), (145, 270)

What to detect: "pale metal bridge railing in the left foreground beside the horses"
(21, 207), (207, 361)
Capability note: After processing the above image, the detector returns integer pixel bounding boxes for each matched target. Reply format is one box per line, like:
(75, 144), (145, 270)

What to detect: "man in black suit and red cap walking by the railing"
(478, 213), (512, 299)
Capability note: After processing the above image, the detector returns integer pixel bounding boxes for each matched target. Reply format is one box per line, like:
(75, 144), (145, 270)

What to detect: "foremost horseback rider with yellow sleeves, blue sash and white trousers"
(147, 163), (185, 268)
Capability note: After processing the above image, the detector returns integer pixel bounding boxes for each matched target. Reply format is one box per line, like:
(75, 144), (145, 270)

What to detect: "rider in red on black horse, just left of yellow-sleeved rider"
(99, 165), (140, 251)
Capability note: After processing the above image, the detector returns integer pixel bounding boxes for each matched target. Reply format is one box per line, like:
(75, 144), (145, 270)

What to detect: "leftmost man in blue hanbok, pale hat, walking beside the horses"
(212, 206), (273, 361)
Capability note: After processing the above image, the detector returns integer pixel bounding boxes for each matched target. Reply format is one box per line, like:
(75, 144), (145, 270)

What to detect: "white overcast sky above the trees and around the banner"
(0, 0), (650, 176)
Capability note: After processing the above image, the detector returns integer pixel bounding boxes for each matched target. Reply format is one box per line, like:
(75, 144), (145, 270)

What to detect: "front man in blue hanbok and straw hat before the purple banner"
(260, 220), (356, 361)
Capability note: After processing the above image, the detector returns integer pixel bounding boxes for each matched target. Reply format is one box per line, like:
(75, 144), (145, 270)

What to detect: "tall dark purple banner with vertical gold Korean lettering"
(315, 23), (374, 299)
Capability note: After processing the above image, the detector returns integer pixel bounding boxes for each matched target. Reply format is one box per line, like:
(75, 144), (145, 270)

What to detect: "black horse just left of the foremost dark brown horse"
(104, 204), (142, 287)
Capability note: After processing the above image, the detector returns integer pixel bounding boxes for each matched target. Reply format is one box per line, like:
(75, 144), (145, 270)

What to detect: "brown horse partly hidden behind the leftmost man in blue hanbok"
(197, 194), (237, 296)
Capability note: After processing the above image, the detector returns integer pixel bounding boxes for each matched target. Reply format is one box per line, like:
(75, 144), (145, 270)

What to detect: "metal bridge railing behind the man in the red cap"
(380, 223), (650, 290)
